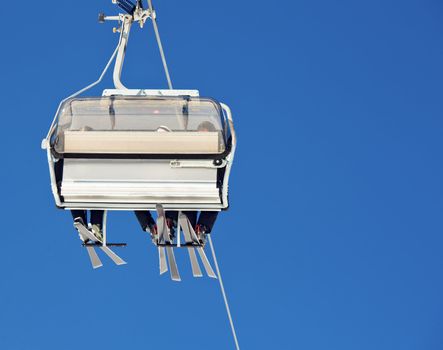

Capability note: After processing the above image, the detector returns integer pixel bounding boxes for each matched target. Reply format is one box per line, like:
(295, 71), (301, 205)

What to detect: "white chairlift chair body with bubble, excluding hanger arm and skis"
(47, 90), (234, 211)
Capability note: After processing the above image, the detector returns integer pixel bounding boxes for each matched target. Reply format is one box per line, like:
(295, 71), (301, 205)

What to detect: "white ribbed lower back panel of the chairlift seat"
(61, 159), (221, 205)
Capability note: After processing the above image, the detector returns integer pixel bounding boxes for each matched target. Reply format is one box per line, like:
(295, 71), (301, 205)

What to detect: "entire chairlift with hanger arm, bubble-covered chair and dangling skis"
(42, 0), (236, 281)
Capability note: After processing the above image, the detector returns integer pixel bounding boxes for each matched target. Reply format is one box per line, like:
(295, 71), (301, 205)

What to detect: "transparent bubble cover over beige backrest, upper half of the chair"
(51, 96), (227, 154)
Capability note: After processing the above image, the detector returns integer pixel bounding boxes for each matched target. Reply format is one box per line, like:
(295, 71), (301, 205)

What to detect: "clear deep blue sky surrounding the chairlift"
(0, 0), (443, 350)
